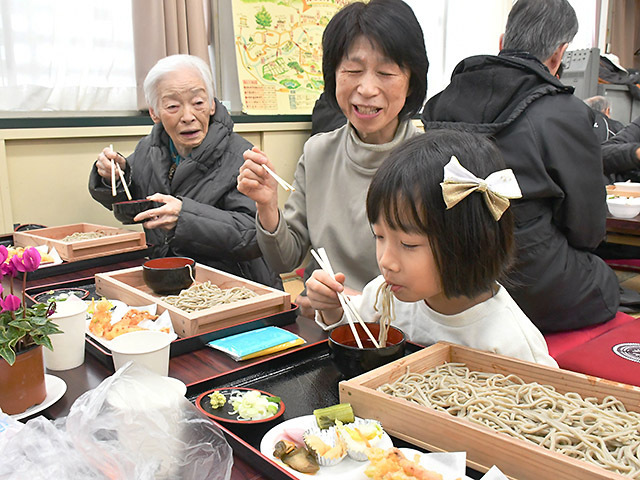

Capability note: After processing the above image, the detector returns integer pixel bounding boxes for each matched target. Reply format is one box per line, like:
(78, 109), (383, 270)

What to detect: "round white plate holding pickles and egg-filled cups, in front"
(260, 415), (393, 480)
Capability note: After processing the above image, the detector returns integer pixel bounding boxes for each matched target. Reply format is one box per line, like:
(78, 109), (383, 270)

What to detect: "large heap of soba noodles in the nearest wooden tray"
(378, 363), (640, 479)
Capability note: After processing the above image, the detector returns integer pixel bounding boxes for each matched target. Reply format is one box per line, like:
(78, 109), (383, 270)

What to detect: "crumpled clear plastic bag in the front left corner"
(0, 364), (233, 480)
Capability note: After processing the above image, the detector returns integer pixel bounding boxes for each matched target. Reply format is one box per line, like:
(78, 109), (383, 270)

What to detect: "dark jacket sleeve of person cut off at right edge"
(602, 117), (640, 183)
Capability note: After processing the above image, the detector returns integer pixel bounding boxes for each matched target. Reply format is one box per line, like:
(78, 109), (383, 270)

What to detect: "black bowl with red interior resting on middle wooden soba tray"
(142, 257), (196, 295)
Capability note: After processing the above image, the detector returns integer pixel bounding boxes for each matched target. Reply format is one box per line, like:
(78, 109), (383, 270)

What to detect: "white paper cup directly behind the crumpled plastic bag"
(109, 330), (178, 376)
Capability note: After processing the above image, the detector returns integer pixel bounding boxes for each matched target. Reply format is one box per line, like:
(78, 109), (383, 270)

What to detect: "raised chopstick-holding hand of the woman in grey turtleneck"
(238, 147), (279, 232)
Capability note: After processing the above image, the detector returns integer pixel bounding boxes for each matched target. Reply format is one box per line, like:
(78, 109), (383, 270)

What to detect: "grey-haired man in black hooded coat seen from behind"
(422, 0), (619, 332)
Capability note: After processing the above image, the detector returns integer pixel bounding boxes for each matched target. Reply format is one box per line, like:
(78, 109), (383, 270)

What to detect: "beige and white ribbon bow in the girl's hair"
(440, 156), (522, 221)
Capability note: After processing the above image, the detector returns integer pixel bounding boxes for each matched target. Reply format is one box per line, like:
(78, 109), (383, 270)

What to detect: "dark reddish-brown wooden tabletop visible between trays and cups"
(17, 259), (327, 480)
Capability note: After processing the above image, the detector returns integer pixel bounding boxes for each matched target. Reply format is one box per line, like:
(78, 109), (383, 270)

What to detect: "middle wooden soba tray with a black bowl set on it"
(95, 264), (291, 337)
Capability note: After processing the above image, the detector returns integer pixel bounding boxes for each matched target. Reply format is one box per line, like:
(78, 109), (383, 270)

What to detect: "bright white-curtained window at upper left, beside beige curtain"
(0, 0), (136, 111)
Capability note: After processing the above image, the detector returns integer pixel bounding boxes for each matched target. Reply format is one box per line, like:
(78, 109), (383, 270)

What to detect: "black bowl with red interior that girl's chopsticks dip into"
(329, 323), (406, 378)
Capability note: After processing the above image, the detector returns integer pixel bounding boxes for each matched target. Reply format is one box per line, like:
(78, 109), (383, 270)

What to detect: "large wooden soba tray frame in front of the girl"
(340, 343), (640, 480)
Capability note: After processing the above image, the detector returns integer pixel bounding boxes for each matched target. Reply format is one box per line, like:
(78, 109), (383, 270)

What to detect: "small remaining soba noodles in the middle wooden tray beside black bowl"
(162, 281), (258, 312)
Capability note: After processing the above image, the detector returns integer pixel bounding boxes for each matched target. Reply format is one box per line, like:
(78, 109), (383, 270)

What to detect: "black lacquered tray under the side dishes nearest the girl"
(187, 340), (444, 480)
